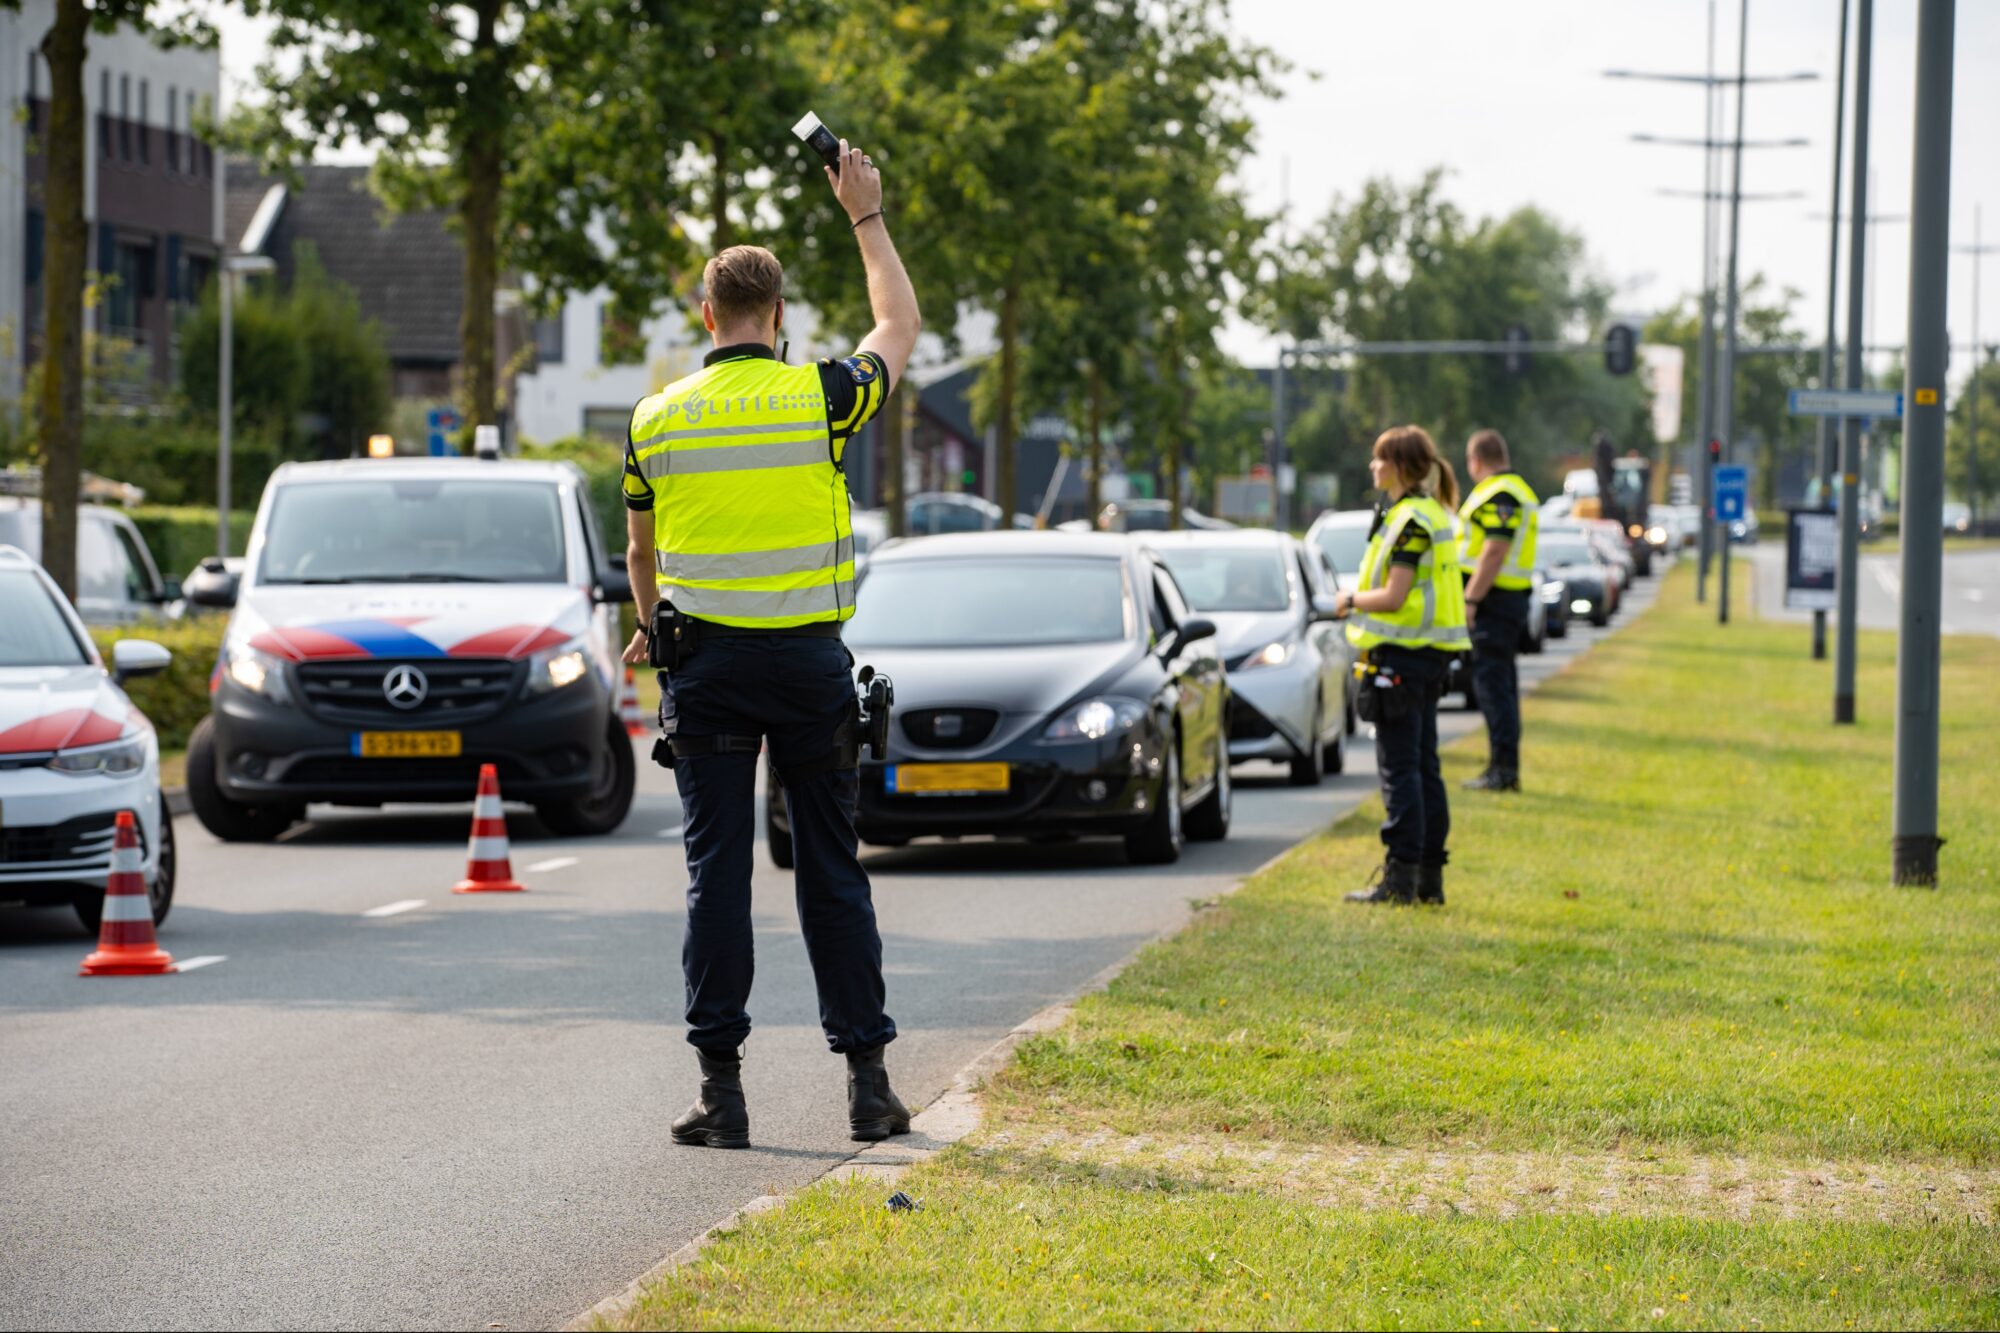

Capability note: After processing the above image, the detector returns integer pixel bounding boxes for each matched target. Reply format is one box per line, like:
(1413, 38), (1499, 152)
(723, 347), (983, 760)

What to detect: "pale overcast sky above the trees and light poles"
(218, 0), (2000, 378)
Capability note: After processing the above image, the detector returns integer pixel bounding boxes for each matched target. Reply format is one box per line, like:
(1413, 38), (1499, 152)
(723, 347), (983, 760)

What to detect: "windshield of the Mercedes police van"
(258, 476), (566, 584)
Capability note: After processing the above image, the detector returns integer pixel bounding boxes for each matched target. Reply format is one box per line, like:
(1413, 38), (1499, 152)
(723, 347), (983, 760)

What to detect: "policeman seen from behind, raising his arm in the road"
(624, 142), (918, 1147)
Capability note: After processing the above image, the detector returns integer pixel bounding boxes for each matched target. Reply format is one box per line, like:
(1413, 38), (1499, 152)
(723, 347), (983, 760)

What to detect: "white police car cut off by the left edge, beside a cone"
(0, 546), (174, 931)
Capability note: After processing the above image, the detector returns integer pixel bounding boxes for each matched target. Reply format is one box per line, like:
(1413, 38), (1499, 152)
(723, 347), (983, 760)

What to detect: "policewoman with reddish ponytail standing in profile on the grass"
(1336, 426), (1466, 907)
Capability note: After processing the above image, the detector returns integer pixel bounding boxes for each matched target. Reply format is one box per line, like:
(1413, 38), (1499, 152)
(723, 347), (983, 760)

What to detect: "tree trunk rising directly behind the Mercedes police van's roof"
(458, 0), (508, 434)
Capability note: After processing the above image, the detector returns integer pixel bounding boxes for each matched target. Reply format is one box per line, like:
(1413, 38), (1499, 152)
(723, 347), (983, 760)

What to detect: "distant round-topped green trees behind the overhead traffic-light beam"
(1254, 170), (1652, 494)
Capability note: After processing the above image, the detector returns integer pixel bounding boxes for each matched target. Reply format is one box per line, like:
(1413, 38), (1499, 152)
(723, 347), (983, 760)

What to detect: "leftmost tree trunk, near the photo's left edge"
(37, 0), (90, 600)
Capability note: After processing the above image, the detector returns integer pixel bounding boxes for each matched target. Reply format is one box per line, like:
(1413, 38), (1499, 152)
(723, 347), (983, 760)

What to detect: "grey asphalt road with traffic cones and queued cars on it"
(0, 584), (1652, 1329)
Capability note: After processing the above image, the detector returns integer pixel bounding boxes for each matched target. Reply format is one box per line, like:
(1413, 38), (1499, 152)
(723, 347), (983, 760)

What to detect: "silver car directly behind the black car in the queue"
(1140, 528), (1354, 787)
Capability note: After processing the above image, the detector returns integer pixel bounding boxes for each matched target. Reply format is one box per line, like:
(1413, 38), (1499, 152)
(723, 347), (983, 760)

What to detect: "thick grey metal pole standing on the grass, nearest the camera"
(1894, 0), (1954, 887)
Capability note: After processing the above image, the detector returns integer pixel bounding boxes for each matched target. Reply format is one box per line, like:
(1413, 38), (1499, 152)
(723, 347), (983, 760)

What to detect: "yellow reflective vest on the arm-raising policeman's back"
(632, 356), (854, 628)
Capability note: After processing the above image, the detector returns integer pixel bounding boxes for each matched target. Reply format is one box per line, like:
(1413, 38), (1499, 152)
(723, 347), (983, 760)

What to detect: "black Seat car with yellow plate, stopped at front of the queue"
(764, 532), (1230, 867)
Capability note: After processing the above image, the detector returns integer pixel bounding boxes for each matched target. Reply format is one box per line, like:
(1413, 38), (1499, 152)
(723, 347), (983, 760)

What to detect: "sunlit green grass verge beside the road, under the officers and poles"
(596, 568), (2000, 1329)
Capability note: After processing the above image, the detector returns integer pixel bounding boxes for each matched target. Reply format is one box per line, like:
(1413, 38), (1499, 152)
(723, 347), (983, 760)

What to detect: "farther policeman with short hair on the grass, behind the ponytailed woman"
(1458, 430), (1542, 791)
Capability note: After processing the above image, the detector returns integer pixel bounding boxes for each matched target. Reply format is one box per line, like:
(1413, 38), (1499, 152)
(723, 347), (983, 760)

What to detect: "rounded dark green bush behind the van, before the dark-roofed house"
(180, 242), (390, 458)
